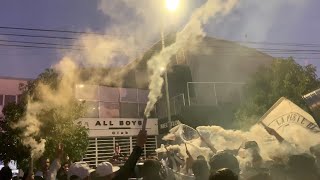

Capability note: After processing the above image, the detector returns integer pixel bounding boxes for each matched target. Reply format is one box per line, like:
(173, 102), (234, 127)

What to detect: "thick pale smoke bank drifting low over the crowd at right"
(157, 125), (320, 166)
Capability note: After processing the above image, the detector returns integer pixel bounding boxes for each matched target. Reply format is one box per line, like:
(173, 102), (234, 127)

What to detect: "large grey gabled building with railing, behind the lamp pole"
(139, 35), (274, 131)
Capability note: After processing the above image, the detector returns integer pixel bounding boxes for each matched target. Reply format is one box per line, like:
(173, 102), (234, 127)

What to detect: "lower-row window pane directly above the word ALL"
(100, 102), (120, 118)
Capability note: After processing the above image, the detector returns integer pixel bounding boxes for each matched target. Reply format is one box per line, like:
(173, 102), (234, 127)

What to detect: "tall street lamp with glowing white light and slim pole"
(161, 0), (180, 130)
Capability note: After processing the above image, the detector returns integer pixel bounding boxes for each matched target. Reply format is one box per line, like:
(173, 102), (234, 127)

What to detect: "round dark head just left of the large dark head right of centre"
(192, 160), (209, 180)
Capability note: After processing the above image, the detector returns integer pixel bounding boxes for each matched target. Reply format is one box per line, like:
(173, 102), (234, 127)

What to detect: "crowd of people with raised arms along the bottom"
(0, 126), (320, 180)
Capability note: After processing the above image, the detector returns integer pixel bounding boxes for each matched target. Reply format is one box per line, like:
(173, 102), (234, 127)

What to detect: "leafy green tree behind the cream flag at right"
(235, 58), (320, 128)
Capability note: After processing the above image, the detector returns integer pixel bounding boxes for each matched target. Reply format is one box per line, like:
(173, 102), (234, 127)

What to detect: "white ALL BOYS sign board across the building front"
(77, 118), (159, 137)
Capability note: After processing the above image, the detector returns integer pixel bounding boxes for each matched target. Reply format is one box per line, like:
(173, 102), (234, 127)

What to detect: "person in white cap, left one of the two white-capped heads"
(68, 162), (94, 180)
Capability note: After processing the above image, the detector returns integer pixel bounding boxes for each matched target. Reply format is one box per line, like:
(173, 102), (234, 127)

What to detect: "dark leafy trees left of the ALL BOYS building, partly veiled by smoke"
(0, 69), (89, 168)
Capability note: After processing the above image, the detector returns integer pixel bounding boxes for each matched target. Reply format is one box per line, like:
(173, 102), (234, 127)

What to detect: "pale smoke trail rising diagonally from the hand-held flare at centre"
(145, 0), (238, 116)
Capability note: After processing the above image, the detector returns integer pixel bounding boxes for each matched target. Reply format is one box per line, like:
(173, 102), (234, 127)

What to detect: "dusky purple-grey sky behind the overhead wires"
(0, 0), (320, 78)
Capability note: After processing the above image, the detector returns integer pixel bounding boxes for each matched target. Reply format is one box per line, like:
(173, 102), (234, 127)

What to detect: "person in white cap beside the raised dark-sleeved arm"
(95, 162), (120, 180)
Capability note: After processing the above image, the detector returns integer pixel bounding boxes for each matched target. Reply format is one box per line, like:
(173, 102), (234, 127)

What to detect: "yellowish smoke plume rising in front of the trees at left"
(12, 58), (77, 159)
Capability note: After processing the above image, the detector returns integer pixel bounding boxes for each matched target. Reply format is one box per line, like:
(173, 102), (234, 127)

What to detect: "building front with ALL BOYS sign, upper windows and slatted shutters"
(75, 84), (159, 166)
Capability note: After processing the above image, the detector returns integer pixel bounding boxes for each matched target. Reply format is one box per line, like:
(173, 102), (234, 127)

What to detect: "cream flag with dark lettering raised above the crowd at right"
(261, 97), (320, 135)
